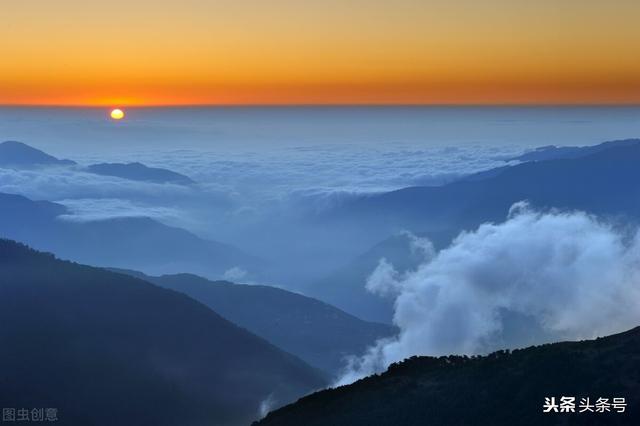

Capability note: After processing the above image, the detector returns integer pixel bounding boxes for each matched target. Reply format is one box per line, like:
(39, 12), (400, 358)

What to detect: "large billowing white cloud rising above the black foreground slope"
(338, 203), (640, 384)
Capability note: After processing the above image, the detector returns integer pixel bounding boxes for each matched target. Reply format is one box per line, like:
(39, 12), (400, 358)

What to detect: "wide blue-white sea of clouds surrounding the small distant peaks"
(0, 145), (522, 234)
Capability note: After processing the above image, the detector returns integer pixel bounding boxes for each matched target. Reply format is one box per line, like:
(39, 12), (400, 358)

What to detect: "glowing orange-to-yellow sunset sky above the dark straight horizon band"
(0, 0), (640, 106)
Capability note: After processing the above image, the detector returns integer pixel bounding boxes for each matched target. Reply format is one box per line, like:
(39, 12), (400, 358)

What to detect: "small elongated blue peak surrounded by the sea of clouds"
(86, 163), (195, 185)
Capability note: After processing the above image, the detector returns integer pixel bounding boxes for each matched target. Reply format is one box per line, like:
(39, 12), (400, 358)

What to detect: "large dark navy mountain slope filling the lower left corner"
(0, 240), (325, 426)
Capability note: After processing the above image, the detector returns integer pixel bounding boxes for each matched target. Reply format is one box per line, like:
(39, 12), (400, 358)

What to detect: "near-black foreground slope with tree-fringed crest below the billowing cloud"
(257, 328), (640, 426)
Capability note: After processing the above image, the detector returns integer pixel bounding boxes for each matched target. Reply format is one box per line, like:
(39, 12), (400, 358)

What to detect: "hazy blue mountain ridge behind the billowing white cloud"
(308, 142), (640, 322)
